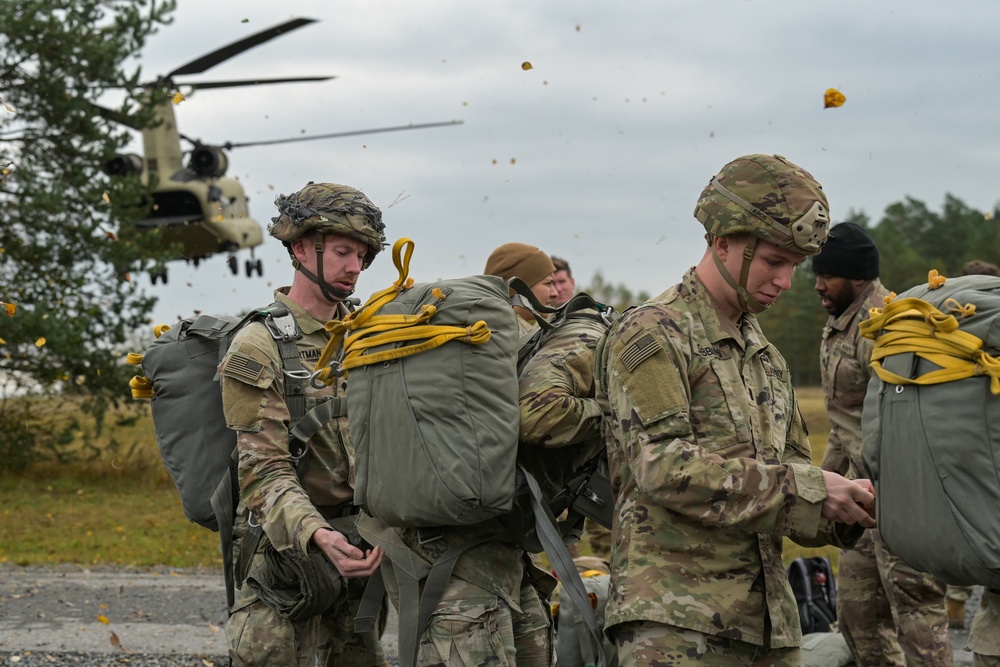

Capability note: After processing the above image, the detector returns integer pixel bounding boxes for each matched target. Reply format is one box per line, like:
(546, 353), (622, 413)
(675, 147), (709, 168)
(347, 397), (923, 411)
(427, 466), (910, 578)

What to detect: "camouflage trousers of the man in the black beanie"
(837, 529), (952, 667)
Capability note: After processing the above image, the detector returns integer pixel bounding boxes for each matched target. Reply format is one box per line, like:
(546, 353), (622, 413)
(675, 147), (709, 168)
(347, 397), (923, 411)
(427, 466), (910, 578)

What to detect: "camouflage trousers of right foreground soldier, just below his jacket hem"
(611, 621), (802, 667)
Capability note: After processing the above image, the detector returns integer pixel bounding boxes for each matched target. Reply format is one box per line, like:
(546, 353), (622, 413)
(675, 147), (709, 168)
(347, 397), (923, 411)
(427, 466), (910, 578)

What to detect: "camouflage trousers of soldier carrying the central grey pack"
(382, 567), (554, 667)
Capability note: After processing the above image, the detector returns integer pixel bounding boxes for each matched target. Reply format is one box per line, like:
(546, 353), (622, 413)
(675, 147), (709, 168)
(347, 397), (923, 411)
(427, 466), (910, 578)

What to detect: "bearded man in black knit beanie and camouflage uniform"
(812, 222), (952, 667)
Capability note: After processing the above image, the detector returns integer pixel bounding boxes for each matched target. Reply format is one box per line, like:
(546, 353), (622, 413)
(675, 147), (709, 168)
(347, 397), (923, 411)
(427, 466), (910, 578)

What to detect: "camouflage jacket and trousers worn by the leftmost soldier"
(220, 290), (384, 667)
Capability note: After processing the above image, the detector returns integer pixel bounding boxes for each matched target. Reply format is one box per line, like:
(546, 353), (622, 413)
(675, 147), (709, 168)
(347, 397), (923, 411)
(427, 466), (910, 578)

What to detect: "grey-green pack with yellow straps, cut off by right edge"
(860, 271), (1000, 588)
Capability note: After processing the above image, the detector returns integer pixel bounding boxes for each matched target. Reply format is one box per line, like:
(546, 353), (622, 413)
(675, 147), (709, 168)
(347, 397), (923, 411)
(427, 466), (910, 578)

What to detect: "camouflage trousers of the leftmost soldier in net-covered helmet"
(226, 579), (387, 667)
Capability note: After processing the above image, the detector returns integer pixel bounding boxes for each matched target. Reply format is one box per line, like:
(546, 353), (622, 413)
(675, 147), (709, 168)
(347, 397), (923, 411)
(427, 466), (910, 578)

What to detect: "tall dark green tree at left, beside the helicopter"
(0, 0), (174, 465)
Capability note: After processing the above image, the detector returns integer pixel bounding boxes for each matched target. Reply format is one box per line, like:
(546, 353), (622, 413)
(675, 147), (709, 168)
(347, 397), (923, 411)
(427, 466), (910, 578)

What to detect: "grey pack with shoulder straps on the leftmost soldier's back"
(128, 302), (336, 605)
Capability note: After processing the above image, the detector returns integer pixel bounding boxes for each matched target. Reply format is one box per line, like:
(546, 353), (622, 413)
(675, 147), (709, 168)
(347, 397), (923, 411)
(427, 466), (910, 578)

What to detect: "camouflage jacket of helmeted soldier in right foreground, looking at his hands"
(601, 269), (861, 648)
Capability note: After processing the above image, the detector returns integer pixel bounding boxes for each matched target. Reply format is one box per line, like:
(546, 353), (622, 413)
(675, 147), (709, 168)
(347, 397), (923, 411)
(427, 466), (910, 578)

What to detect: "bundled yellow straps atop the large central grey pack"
(314, 238), (492, 384)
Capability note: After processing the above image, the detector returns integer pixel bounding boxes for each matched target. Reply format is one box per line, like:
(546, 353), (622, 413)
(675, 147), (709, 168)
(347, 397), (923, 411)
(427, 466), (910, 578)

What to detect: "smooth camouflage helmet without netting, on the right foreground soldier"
(694, 155), (830, 255)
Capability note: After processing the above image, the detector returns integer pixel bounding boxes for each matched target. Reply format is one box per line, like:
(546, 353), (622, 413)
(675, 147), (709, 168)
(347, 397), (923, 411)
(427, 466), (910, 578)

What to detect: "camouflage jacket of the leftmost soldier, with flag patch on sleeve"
(220, 290), (354, 596)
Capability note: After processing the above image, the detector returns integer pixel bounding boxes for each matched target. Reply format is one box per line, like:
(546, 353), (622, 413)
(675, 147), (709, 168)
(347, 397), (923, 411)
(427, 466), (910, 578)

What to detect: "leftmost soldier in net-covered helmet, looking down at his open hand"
(220, 183), (386, 667)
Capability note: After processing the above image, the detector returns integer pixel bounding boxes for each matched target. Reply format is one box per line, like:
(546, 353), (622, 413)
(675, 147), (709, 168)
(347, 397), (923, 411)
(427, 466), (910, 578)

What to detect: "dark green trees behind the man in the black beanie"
(759, 194), (1000, 385)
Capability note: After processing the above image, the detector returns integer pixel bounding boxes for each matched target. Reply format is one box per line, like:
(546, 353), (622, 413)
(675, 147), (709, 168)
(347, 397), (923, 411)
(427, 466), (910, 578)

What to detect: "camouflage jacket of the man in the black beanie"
(819, 278), (889, 479)
